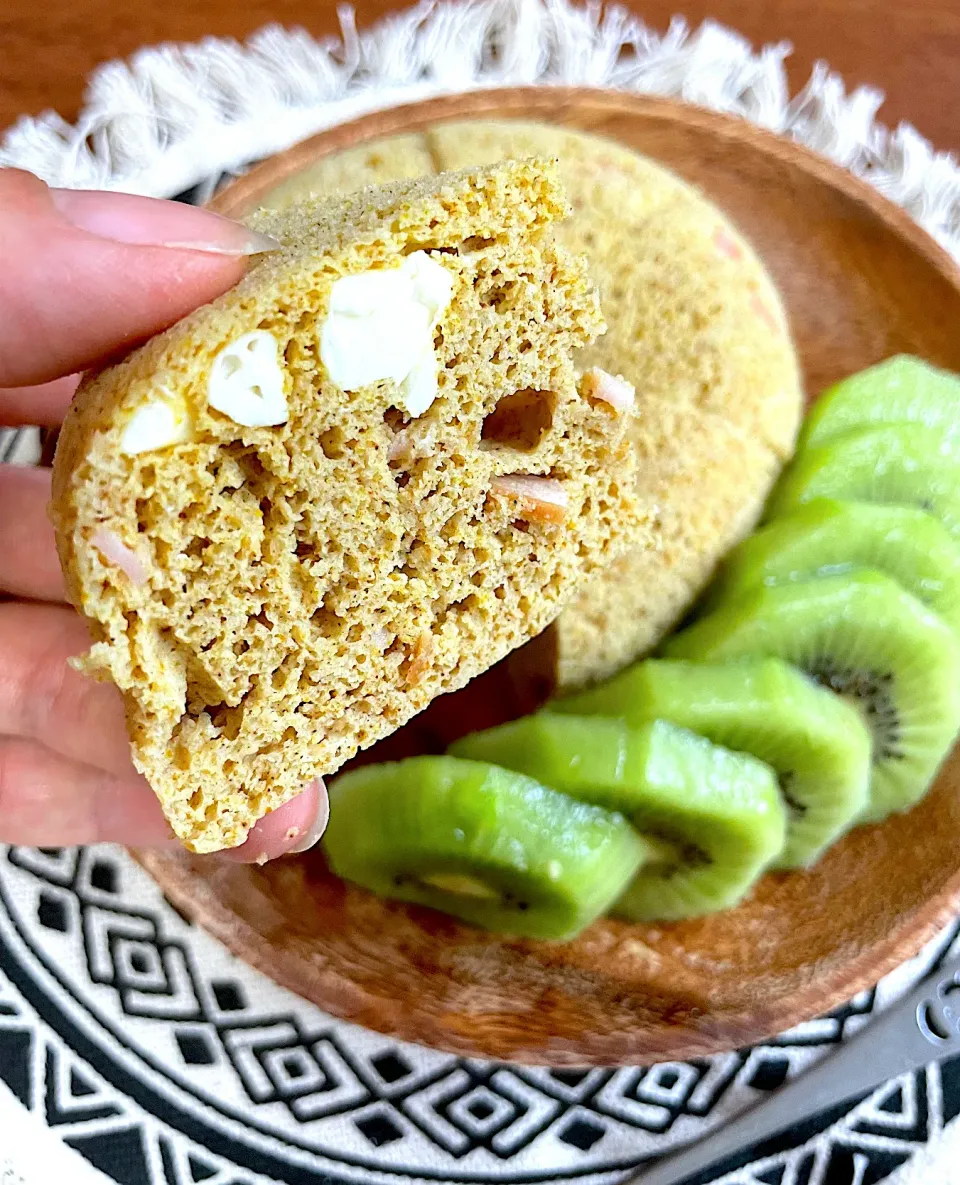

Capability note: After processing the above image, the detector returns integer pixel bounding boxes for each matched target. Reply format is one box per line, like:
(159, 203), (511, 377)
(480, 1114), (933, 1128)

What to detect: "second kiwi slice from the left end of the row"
(452, 712), (786, 922)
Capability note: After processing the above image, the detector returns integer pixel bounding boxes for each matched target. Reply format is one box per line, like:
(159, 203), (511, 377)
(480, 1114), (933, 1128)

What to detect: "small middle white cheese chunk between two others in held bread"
(206, 329), (290, 428)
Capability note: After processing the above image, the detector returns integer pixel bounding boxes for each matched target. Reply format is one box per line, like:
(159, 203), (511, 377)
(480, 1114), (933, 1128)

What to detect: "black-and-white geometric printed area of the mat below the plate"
(0, 846), (960, 1185)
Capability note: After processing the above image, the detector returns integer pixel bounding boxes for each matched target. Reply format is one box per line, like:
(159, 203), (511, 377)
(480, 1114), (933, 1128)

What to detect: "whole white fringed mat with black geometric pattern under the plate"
(0, 0), (960, 1185)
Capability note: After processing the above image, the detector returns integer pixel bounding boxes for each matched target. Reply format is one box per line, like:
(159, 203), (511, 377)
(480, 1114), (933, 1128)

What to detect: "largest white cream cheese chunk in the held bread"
(320, 251), (453, 416)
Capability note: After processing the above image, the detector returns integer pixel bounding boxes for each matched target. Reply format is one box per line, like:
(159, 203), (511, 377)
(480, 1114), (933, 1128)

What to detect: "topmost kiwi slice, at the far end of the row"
(800, 354), (960, 446)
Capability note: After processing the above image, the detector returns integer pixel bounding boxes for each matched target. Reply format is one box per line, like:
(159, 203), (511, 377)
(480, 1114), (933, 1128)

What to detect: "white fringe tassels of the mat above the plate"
(0, 0), (960, 260)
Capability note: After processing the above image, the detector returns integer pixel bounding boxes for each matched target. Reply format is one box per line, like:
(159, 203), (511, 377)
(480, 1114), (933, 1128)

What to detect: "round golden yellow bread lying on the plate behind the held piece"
(254, 121), (802, 687)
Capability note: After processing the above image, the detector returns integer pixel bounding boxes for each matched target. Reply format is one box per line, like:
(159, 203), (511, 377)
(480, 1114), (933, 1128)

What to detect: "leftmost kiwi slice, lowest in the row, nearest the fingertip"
(324, 757), (648, 939)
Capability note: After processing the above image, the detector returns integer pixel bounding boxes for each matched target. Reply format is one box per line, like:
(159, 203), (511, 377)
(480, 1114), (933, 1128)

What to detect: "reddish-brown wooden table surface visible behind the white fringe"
(0, 0), (960, 149)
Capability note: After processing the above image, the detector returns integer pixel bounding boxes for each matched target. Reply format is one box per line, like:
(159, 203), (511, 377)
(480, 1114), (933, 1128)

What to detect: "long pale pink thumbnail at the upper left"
(50, 190), (283, 256)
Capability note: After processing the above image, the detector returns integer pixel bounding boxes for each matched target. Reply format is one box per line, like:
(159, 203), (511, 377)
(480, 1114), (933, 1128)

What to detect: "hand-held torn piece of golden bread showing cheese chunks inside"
(52, 161), (647, 852)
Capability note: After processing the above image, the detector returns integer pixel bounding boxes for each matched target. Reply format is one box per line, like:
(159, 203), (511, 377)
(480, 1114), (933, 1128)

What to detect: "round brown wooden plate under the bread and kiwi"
(140, 83), (960, 1065)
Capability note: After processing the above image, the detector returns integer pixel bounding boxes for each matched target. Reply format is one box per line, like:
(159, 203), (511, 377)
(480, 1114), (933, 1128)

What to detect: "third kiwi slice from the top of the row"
(704, 498), (960, 633)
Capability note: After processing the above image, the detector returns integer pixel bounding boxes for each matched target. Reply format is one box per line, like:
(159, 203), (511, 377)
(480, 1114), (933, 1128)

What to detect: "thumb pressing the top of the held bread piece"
(0, 169), (279, 386)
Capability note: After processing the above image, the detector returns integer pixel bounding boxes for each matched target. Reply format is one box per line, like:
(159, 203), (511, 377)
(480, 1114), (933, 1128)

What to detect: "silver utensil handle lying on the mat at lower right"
(621, 959), (960, 1185)
